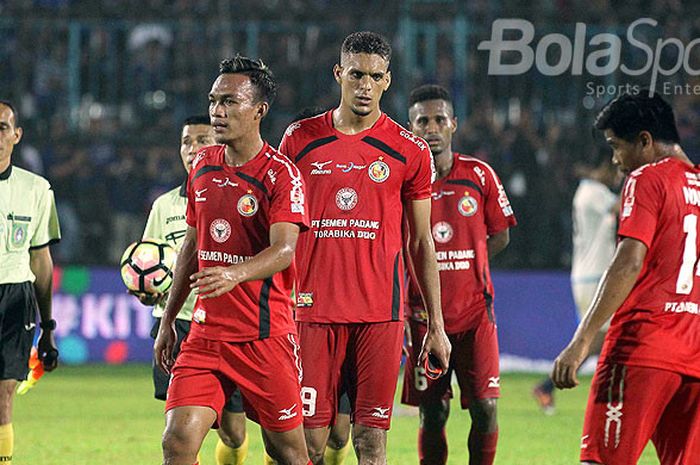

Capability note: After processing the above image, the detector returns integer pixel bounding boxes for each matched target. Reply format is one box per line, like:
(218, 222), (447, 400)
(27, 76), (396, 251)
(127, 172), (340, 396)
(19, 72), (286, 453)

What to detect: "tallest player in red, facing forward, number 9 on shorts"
(280, 32), (450, 465)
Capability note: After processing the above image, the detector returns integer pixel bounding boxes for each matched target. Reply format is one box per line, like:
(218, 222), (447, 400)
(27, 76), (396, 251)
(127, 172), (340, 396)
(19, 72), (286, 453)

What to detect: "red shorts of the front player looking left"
(165, 334), (302, 432)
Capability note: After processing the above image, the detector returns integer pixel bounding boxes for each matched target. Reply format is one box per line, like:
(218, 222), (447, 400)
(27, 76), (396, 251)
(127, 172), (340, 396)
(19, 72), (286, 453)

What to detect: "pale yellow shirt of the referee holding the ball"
(143, 184), (195, 321)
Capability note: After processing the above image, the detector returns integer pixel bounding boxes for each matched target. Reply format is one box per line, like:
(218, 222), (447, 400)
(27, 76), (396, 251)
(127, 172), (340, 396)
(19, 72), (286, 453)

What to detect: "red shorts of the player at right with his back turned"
(581, 361), (700, 465)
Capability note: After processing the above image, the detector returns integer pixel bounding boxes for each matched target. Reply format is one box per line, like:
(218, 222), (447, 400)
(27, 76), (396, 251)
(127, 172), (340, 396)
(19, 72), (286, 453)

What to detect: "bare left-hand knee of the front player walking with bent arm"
(162, 406), (216, 465)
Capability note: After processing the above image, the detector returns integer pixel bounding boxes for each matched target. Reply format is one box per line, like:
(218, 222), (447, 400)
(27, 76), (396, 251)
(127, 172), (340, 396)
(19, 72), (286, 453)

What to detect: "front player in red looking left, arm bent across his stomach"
(154, 56), (309, 465)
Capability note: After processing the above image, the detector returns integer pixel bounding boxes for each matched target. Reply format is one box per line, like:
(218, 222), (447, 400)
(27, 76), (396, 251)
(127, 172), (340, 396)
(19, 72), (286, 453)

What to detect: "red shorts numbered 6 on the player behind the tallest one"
(401, 312), (501, 409)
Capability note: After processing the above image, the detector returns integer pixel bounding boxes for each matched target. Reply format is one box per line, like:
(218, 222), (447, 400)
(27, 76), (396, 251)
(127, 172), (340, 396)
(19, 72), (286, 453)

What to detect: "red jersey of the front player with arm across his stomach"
(187, 144), (308, 342)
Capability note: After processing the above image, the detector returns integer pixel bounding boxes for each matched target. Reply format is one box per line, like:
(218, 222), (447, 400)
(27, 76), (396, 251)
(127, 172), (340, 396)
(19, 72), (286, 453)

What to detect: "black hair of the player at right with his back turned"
(594, 90), (680, 143)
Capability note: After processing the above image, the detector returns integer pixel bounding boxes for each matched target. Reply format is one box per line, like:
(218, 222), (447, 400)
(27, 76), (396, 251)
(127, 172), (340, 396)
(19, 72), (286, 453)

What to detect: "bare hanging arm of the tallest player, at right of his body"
(405, 198), (451, 370)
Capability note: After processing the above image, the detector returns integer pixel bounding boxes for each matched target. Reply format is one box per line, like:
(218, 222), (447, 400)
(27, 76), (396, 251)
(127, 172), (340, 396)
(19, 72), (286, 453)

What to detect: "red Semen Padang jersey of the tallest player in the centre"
(280, 111), (433, 323)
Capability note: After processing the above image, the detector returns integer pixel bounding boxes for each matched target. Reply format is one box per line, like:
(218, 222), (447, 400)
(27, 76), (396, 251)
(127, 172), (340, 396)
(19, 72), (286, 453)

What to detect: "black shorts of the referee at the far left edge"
(0, 281), (39, 381)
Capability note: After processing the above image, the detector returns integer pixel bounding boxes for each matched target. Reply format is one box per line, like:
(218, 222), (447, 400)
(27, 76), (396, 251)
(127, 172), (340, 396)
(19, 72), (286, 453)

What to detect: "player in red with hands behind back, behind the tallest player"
(402, 85), (516, 465)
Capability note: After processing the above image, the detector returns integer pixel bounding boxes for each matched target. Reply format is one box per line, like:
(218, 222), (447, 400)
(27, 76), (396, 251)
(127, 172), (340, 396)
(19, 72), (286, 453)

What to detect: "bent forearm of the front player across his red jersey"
(190, 222), (299, 299)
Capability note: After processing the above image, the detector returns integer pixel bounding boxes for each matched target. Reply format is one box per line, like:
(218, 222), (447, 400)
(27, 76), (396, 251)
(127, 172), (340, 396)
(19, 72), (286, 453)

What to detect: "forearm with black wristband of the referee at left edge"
(29, 246), (58, 371)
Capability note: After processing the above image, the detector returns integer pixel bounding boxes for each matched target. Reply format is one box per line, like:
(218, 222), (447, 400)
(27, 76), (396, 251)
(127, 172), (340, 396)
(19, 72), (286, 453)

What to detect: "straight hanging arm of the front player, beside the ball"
(153, 226), (197, 373)
